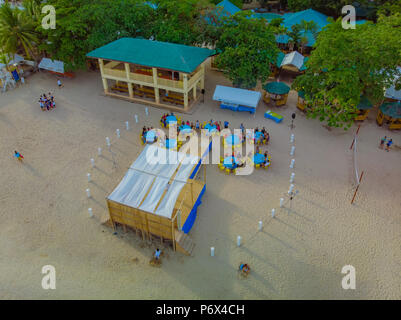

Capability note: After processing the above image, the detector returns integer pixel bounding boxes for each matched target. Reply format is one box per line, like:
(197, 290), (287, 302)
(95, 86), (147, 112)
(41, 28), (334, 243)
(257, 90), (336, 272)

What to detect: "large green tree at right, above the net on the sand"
(293, 15), (401, 129)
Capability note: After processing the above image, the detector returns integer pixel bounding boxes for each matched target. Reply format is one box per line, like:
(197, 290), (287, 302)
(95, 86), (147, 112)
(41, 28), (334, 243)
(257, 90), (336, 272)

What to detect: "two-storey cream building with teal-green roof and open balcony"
(87, 38), (214, 112)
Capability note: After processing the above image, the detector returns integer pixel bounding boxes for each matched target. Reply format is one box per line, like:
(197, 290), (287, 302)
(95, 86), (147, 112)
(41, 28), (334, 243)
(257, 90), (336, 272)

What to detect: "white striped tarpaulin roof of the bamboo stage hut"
(108, 145), (199, 218)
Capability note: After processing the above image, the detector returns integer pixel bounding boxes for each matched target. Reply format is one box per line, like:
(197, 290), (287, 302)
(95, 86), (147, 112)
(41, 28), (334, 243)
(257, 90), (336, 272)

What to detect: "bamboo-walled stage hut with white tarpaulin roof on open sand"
(106, 143), (211, 255)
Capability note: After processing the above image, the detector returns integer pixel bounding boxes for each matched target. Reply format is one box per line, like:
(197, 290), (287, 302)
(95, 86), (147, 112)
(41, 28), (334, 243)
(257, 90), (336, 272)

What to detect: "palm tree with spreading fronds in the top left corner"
(0, 1), (38, 58)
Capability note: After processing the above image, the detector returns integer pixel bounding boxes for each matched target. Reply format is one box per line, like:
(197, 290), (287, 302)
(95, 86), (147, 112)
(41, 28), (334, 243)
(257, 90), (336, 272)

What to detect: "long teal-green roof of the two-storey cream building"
(86, 38), (215, 73)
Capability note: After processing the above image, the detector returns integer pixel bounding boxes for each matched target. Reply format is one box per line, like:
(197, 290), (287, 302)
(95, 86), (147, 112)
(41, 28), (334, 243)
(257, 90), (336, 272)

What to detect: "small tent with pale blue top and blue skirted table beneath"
(213, 85), (262, 114)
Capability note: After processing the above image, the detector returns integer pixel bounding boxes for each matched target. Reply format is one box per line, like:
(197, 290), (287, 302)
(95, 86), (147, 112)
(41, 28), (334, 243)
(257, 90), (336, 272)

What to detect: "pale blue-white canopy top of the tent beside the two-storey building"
(213, 85), (261, 108)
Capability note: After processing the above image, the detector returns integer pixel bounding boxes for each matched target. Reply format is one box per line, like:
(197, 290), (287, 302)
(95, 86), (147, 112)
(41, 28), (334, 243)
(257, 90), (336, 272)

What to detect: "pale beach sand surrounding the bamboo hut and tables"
(0, 61), (401, 299)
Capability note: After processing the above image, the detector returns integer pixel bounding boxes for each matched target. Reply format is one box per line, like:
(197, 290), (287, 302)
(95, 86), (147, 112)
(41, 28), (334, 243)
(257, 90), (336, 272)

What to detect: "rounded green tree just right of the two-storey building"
(216, 12), (279, 88)
